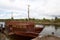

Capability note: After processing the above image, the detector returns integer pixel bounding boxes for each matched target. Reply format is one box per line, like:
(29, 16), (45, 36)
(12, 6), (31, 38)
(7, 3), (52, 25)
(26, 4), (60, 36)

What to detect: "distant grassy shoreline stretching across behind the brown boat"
(0, 19), (60, 25)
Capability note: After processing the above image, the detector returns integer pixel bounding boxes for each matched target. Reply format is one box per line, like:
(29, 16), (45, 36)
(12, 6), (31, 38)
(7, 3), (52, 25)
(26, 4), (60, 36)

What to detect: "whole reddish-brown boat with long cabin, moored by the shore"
(5, 21), (43, 38)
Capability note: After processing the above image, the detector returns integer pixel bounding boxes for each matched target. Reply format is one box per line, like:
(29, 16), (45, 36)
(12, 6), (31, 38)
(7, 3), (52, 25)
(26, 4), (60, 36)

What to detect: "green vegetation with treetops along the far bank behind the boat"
(0, 17), (60, 25)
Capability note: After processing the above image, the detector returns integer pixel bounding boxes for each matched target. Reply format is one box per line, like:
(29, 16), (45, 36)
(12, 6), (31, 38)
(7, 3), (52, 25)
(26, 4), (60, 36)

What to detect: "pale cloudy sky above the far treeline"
(0, 0), (60, 19)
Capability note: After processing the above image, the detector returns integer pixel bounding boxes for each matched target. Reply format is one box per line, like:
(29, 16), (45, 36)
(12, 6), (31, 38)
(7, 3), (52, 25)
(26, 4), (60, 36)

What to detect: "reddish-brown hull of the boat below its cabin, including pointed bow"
(8, 28), (43, 38)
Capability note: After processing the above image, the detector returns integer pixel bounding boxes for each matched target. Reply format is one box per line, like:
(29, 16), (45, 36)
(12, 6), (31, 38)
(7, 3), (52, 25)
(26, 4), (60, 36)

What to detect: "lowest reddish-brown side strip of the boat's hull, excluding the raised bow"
(9, 31), (38, 38)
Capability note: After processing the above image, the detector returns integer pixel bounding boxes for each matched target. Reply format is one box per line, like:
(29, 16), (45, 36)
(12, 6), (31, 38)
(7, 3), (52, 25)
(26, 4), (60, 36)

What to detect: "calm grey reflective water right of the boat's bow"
(40, 25), (60, 37)
